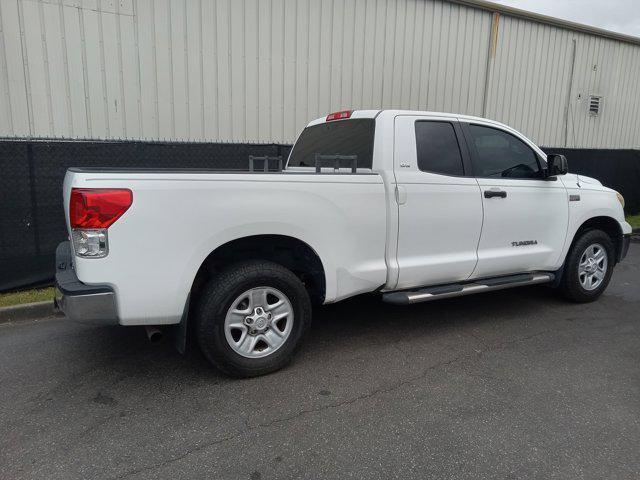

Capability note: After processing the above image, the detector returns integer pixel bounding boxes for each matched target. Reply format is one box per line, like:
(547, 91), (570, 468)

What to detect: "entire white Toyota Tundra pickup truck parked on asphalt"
(56, 110), (631, 376)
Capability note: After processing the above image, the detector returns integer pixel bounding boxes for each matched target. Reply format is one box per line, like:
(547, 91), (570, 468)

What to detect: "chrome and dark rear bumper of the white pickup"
(55, 242), (119, 325)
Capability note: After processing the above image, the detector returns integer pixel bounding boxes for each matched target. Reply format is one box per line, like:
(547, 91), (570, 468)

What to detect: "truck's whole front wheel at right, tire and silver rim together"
(560, 230), (615, 302)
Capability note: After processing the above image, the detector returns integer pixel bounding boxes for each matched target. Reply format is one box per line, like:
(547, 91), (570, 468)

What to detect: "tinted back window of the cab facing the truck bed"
(288, 118), (376, 168)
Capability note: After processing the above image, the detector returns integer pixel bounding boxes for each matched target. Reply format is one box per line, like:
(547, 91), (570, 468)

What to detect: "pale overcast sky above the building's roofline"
(492, 0), (640, 37)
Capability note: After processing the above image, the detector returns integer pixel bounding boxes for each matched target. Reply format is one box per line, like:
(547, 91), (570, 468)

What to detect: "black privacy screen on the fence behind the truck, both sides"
(0, 140), (640, 291)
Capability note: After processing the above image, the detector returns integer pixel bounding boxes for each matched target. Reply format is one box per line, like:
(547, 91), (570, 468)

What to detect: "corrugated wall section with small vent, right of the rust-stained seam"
(486, 16), (640, 148)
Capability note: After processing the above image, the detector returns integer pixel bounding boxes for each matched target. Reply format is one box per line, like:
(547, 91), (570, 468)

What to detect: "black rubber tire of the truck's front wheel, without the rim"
(559, 230), (615, 303)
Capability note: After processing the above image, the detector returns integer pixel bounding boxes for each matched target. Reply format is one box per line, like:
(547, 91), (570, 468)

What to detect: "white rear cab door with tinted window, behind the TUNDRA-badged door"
(394, 115), (482, 288)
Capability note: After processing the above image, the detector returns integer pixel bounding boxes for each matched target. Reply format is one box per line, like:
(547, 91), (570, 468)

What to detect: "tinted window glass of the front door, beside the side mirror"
(469, 125), (541, 178)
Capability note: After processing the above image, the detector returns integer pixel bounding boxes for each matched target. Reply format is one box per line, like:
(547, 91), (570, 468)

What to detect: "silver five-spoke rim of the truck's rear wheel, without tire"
(224, 287), (294, 358)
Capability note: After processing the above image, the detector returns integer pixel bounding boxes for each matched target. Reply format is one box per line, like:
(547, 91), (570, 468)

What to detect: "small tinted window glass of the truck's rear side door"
(416, 121), (464, 175)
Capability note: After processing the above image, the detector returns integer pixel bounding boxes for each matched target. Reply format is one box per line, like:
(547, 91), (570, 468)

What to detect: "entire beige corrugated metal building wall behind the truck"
(0, 0), (640, 148)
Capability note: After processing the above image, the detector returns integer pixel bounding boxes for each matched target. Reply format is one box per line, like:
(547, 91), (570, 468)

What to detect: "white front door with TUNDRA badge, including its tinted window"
(461, 123), (569, 278)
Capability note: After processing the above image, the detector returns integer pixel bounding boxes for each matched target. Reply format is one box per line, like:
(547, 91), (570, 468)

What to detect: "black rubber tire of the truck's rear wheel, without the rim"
(195, 260), (311, 377)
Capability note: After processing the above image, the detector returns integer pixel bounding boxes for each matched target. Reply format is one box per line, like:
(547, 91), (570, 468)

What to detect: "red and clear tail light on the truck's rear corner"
(69, 188), (133, 258)
